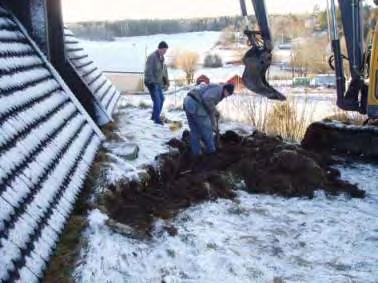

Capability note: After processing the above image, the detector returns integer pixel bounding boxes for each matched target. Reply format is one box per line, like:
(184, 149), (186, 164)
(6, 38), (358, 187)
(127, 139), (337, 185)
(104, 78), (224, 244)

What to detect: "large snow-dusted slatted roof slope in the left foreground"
(0, 6), (103, 282)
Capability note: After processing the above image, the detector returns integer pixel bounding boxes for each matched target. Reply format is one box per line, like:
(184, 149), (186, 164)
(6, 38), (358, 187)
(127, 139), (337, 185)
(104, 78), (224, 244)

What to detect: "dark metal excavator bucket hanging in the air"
(243, 48), (286, 100)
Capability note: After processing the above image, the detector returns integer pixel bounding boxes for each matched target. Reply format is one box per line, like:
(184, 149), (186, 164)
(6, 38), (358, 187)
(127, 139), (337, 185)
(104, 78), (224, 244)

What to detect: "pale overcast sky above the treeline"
(62, 0), (373, 22)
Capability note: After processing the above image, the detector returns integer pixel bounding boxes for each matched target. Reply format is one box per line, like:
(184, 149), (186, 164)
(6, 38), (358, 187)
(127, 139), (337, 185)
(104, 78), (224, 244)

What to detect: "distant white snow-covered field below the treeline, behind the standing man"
(77, 31), (287, 82)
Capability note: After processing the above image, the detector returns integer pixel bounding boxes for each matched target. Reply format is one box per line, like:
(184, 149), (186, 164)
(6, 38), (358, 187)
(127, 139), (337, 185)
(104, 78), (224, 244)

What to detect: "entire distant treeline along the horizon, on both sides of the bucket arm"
(68, 5), (378, 42)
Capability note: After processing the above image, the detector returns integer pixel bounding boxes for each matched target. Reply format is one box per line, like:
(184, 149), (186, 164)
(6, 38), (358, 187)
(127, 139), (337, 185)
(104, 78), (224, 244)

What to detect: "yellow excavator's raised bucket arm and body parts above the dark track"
(240, 0), (378, 118)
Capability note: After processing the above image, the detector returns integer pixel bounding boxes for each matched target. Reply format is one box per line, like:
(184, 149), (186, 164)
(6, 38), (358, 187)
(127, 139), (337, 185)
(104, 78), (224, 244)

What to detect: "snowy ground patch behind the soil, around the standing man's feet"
(97, 90), (253, 186)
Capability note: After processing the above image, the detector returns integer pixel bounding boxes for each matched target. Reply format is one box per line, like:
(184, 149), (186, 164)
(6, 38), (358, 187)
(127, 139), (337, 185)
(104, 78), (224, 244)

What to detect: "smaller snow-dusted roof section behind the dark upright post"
(64, 28), (120, 114)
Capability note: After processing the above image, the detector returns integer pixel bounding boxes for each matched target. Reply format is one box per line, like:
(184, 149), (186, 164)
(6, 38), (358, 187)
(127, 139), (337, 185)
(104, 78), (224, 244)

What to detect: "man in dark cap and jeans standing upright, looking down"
(144, 41), (169, 125)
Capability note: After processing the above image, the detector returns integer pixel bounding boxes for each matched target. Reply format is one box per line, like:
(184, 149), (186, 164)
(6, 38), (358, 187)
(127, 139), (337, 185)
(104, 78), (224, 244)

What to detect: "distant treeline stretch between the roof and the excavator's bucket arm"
(68, 17), (253, 40)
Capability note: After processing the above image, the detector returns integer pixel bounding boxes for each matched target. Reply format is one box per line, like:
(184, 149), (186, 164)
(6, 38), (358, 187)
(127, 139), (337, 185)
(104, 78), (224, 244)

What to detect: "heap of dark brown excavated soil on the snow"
(104, 131), (365, 235)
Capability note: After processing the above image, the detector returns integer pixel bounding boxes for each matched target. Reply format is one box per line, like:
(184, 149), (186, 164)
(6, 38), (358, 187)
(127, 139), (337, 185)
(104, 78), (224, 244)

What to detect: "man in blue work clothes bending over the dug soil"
(184, 84), (234, 156)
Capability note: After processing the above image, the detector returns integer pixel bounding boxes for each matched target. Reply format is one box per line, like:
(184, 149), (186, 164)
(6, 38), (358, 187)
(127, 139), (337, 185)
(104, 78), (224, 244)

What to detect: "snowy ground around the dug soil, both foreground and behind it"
(74, 94), (378, 282)
